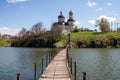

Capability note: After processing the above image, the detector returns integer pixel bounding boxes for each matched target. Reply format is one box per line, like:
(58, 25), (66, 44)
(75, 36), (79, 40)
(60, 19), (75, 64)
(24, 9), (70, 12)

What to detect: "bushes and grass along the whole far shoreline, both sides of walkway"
(0, 31), (120, 48)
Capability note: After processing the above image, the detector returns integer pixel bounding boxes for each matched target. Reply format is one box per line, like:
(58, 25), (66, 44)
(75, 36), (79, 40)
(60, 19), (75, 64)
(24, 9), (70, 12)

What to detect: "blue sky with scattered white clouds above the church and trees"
(0, 0), (120, 35)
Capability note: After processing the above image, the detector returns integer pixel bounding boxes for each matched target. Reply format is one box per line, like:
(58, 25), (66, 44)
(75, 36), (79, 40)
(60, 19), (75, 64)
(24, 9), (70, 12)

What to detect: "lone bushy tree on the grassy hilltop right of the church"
(96, 18), (110, 32)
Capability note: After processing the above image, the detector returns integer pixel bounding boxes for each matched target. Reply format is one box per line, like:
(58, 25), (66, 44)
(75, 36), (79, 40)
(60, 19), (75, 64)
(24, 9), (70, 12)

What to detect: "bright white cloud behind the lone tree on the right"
(88, 15), (116, 25)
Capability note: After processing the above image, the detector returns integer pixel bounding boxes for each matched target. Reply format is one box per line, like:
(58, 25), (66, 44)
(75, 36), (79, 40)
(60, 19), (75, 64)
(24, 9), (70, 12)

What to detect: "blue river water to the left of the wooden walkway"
(0, 47), (49, 80)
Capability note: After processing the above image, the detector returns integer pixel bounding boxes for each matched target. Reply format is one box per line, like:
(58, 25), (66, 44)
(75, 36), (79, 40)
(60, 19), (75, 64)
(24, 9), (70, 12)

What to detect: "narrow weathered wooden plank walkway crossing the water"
(39, 49), (71, 80)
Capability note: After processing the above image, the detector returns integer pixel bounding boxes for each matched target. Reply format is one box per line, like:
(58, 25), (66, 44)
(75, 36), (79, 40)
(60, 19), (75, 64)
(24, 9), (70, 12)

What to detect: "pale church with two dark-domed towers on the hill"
(53, 10), (76, 32)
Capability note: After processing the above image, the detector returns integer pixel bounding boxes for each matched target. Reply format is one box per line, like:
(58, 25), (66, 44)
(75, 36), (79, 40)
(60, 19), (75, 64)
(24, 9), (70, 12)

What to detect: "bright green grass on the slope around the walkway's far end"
(56, 31), (120, 45)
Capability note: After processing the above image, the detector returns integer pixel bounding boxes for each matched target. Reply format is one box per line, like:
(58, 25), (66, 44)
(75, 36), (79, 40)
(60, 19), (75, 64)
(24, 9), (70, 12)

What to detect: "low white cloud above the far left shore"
(0, 27), (20, 35)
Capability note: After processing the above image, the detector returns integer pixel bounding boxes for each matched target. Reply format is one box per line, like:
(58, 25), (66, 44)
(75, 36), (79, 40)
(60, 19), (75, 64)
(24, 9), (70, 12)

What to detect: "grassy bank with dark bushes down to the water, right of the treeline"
(56, 32), (120, 48)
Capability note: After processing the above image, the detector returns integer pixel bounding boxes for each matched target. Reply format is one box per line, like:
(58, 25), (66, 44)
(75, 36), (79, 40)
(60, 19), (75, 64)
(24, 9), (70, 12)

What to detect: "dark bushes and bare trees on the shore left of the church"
(11, 22), (62, 48)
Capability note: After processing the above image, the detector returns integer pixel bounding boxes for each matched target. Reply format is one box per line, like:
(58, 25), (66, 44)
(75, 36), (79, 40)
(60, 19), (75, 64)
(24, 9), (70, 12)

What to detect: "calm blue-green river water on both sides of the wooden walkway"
(0, 47), (120, 80)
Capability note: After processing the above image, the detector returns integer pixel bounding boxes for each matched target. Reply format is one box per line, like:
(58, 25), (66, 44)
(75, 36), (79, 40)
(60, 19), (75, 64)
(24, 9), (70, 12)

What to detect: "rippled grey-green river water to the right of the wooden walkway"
(70, 49), (120, 80)
